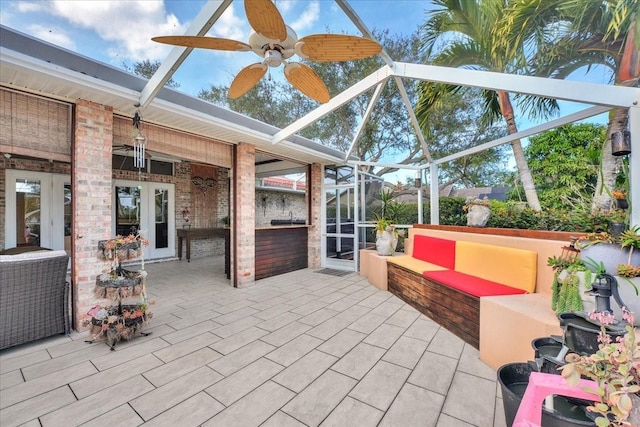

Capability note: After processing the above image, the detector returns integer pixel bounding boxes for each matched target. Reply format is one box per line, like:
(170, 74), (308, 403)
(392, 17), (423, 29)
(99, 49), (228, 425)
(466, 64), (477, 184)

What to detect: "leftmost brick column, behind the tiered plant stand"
(71, 100), (113, 330)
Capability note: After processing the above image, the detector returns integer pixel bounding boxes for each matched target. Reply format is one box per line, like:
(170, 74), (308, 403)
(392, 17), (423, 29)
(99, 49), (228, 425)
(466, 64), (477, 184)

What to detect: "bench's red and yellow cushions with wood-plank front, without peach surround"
(387, 235), (537, 348)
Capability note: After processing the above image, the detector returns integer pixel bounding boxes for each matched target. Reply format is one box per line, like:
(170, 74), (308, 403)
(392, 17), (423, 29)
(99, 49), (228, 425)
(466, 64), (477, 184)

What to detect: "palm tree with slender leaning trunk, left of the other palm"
(416, 0), (558, 211)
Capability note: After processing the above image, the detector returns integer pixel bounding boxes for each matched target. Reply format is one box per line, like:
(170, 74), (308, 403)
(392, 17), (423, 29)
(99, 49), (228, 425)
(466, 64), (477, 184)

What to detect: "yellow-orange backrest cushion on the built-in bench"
(452, 242), (538, 292)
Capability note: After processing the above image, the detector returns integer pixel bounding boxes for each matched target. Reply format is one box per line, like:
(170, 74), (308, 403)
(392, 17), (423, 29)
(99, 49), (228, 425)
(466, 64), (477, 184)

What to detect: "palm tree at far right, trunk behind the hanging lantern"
(497, 0), (640, 212)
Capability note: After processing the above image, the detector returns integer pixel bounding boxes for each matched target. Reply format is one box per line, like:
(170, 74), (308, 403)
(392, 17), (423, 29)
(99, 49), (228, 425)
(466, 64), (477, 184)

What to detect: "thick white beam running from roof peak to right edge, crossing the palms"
(393, 62), (640, 108)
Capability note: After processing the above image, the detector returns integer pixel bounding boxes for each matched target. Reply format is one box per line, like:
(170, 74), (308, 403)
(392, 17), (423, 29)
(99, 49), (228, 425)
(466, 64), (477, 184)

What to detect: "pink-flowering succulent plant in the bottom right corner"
(561, 311), (640, 427)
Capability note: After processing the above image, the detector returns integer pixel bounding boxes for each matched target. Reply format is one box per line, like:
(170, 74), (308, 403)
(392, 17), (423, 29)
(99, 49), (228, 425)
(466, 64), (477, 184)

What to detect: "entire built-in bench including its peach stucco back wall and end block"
(380, 224), (575, 369)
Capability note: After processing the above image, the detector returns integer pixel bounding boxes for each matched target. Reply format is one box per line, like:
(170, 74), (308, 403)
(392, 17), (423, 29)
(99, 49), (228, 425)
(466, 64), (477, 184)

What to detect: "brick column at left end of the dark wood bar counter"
(233, 144), (256, 288)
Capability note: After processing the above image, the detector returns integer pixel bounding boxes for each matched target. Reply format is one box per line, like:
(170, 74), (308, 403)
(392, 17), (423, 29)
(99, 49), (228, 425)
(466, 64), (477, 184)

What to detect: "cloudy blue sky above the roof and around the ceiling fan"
(0, 0), (430, 95)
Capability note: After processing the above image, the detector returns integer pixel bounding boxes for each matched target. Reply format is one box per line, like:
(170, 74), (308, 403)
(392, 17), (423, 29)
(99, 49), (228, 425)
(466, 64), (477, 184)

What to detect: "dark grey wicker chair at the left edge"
(0, 251), (70, 349)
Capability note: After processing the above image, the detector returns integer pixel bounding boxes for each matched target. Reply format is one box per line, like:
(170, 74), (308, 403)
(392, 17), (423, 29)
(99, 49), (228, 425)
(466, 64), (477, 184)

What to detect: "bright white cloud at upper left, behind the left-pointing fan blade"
(43, 0), (186, 61)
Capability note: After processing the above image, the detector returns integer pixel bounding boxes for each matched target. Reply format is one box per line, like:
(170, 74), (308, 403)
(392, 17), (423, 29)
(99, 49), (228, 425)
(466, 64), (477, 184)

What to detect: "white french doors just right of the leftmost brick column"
(112, 180), (175, 259)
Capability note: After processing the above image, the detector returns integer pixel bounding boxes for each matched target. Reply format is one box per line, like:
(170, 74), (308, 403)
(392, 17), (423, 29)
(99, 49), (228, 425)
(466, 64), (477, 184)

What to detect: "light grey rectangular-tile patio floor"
(0, 258), (505, 427)
